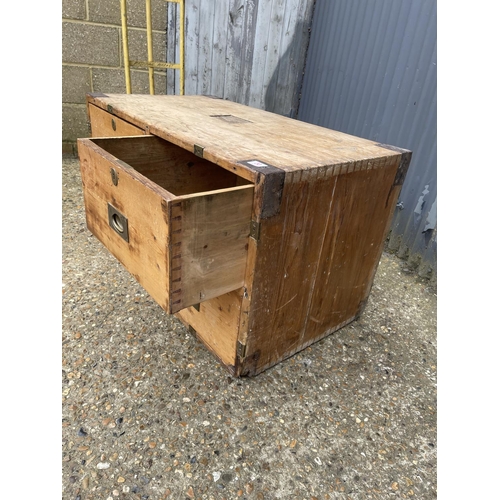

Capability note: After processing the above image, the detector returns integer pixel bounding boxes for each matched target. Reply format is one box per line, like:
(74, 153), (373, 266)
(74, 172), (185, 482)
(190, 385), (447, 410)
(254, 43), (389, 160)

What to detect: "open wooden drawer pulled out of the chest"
(78, 135), (254, 313)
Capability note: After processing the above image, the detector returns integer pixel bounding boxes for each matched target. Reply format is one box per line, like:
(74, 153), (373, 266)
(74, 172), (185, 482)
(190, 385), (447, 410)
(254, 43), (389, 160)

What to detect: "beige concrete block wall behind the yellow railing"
(62, 0), (170, 155)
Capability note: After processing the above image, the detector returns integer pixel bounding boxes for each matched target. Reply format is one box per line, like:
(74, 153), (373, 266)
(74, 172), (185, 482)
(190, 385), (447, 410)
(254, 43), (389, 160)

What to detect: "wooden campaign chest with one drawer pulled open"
(78, 94), (411, 376)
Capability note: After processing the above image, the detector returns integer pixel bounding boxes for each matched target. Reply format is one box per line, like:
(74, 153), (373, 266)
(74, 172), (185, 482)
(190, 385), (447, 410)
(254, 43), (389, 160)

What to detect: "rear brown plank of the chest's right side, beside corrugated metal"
(304, 159), (399, 342)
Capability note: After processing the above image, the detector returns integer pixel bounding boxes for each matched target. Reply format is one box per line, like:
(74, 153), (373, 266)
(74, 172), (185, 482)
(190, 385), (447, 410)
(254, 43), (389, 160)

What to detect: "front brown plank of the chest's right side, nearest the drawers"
(238, 167), (337, 371)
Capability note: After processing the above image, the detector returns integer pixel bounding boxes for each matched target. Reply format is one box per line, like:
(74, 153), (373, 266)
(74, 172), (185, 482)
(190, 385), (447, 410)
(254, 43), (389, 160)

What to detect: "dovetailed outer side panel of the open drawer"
(170, 185), (254, 312)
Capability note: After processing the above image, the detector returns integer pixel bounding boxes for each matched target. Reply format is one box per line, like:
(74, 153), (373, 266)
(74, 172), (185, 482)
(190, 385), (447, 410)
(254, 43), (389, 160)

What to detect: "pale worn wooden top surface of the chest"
(87, 94), (404, 171)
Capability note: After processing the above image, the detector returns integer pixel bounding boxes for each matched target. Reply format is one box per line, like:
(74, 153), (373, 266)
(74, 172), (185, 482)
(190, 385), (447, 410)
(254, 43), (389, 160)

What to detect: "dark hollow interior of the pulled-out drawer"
(92, 135), (251, 196)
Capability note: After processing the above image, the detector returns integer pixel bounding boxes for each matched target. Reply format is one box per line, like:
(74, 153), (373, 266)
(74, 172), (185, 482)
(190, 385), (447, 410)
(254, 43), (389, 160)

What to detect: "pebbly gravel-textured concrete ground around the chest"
(62, 159), (437, 500)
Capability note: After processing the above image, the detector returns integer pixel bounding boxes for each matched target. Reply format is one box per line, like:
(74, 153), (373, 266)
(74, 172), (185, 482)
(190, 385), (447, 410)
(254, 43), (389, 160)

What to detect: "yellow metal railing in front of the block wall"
(120, 0), (184, 95)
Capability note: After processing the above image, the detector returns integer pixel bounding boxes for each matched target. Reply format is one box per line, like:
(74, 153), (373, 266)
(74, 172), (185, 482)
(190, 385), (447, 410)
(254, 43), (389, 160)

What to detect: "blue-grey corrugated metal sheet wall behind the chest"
(298, 0), (437, 277)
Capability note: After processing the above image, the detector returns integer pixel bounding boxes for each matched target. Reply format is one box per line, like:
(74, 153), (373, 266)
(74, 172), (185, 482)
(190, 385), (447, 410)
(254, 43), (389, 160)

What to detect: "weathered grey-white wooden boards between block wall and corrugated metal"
(167, 0), (314, 117)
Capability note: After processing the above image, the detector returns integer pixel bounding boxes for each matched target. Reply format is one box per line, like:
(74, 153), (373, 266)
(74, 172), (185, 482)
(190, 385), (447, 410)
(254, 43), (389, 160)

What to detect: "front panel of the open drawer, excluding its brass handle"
(78, 139), (169, 309)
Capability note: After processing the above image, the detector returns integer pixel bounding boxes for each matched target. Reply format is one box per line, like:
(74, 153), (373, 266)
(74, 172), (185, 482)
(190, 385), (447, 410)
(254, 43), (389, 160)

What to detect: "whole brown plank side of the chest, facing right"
(236, 158), (399, 374)
